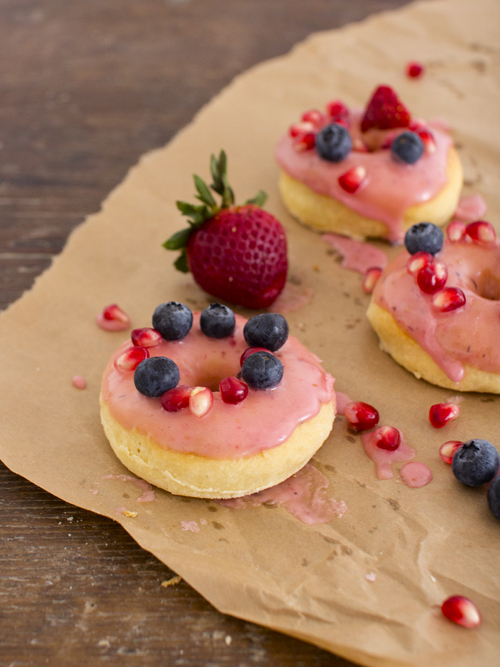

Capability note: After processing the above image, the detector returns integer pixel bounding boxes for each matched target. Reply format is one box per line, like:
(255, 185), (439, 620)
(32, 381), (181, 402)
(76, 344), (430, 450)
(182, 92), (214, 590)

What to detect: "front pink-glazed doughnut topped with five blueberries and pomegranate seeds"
(101, 302), (335, 498)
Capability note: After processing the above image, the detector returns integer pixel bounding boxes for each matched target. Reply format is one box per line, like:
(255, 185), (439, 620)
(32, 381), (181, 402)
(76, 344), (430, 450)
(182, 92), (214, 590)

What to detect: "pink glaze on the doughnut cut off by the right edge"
(373, 239), (500, 382)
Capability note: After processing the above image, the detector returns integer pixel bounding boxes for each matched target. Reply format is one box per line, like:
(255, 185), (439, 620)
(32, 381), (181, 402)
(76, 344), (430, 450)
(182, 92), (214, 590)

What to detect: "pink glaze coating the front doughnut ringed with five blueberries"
(102, 313), (335, 459)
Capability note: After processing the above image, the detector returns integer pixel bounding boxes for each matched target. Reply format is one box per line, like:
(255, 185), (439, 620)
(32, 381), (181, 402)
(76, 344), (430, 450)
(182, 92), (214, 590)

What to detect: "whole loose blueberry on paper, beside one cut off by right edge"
(451, 440), (500, 486)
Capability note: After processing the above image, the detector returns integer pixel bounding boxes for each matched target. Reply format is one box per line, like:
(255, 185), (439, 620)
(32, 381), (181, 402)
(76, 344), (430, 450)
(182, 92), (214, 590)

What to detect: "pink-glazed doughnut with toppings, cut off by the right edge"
(367, 221), (500, 394)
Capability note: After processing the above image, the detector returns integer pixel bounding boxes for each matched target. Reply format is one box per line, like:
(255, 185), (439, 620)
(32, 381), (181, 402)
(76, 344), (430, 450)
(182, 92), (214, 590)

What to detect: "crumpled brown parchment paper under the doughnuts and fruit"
(0, 0), (500, 666)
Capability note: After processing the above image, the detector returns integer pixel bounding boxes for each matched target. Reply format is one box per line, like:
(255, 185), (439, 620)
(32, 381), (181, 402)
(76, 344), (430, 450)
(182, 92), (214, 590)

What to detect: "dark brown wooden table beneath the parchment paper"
(0, 0), (406, 667)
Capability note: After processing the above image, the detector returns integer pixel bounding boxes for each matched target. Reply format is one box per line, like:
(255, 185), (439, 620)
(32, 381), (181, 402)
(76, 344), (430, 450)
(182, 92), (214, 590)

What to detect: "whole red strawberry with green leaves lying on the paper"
(163, 151), (288, 308)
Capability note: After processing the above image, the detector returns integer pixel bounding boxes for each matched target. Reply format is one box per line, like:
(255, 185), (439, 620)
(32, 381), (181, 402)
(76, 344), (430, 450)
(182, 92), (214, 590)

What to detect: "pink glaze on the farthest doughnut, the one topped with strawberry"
(276, 111), (452, 242)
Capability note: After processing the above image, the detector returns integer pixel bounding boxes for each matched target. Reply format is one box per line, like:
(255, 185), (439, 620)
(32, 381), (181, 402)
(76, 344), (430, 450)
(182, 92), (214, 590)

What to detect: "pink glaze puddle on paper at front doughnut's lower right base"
(215, 464), (347, 526)
